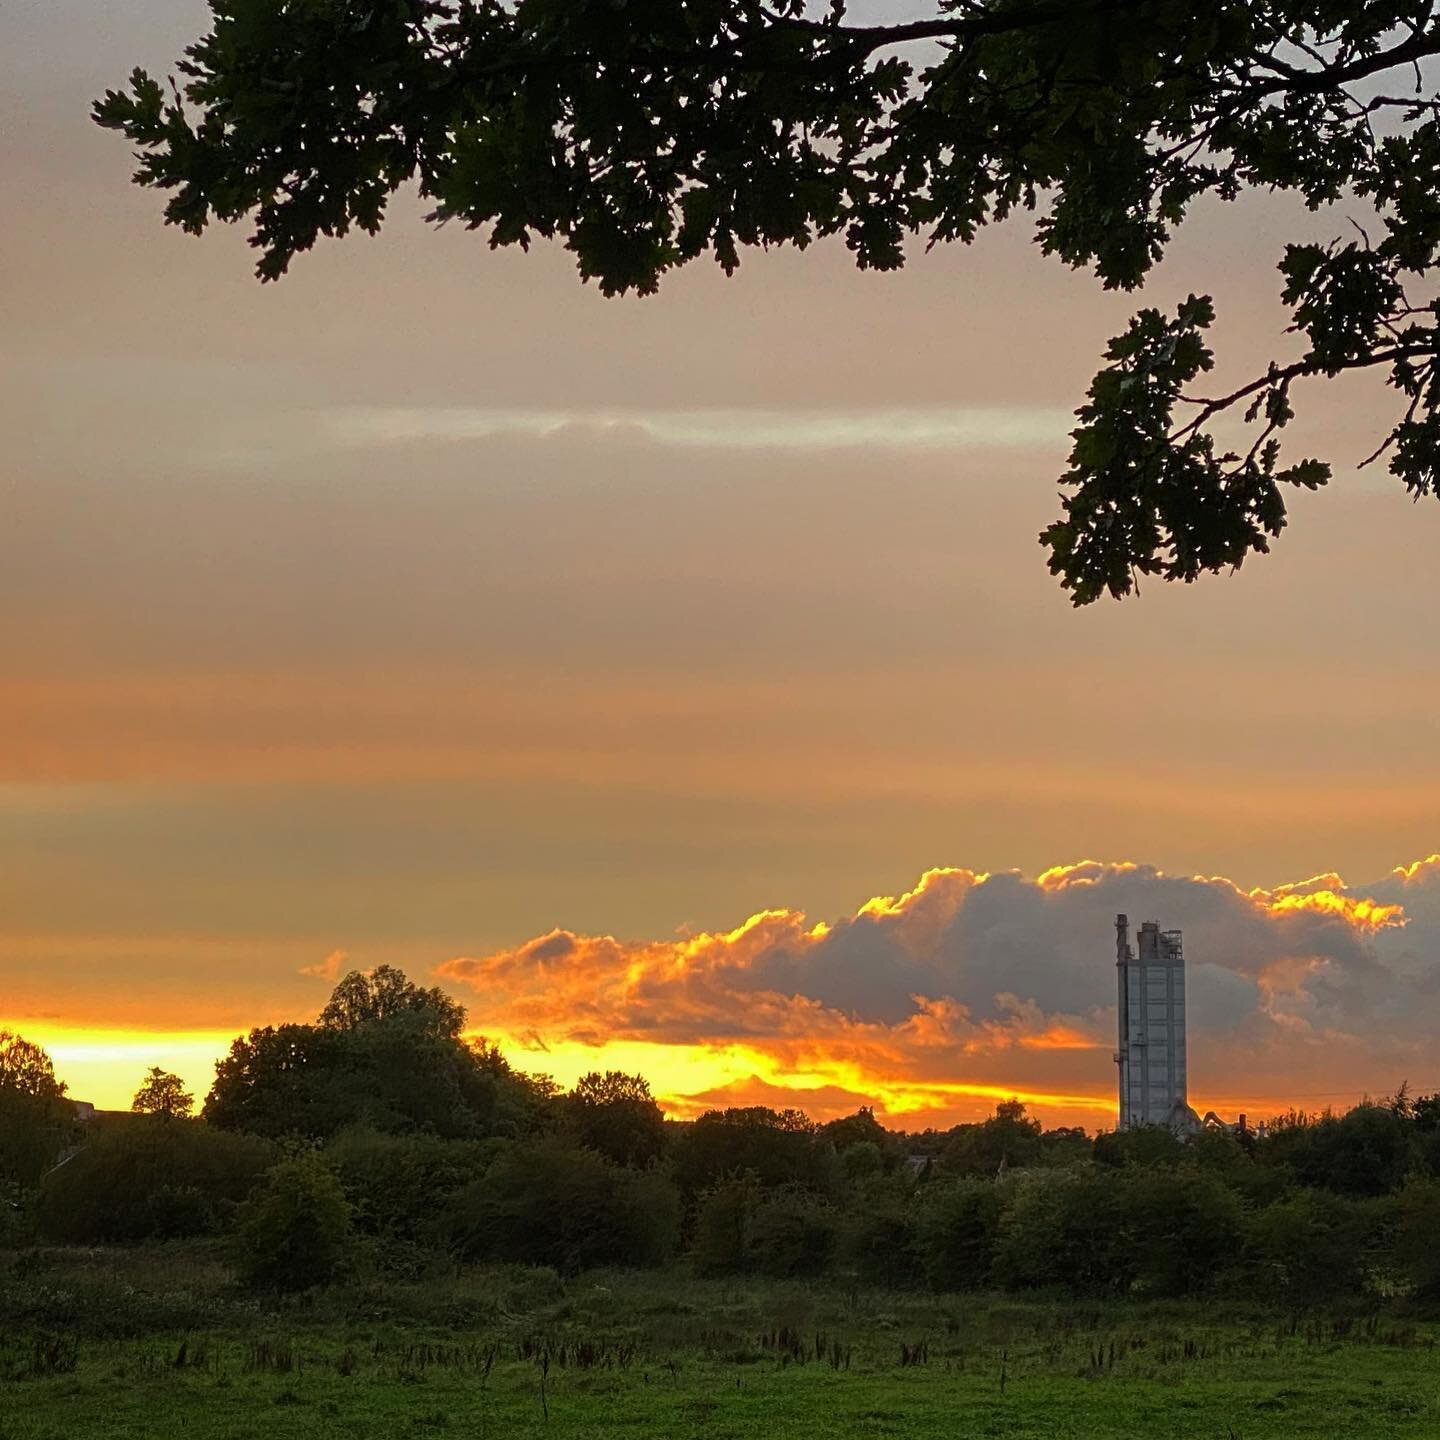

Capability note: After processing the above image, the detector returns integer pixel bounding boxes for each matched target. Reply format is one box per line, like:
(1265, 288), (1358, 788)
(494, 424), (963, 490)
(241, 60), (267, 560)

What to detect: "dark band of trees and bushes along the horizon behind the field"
(0, 966), (1440, 1305)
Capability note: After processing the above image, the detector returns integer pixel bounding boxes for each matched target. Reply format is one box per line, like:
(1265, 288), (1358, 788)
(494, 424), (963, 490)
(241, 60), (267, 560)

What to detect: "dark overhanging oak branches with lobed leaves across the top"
(95, 0), (1440, 605)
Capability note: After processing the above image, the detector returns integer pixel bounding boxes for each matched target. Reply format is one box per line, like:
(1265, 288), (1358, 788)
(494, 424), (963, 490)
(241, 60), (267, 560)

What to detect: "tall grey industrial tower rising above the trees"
(1115, 914), (1200, 1133)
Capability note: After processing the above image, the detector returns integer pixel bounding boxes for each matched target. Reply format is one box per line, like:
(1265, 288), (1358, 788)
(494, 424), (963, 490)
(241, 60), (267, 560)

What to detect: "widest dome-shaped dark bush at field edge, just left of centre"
(449, 1139), (680, 1274)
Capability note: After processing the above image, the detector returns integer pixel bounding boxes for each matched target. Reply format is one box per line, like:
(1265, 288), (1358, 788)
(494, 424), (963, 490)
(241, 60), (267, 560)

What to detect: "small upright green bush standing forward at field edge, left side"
(235, 1152), (353, 1290)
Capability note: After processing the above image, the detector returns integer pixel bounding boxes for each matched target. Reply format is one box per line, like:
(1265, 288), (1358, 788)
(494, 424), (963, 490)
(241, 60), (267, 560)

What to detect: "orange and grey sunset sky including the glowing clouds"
(0, 0), (1440, 1128)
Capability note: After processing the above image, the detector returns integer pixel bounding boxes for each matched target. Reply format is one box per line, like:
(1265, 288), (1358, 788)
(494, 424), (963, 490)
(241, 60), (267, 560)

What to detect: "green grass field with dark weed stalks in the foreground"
(0, 1250), (1440, 1440)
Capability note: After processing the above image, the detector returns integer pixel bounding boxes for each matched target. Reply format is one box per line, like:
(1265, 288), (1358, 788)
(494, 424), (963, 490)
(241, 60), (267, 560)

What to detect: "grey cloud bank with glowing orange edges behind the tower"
(439, 855), (1440, 1126)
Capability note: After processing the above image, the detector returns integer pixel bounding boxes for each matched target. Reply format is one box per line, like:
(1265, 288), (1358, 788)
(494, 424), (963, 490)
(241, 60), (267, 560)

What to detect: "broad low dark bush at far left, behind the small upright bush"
(39, 1116), (275, 1244)
